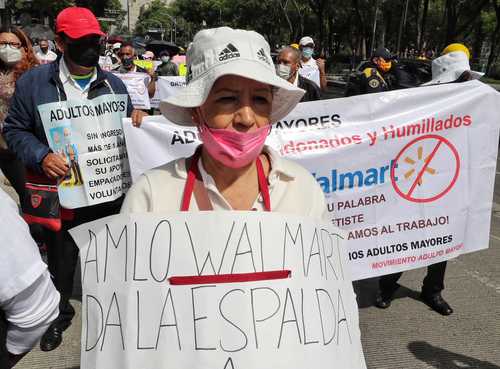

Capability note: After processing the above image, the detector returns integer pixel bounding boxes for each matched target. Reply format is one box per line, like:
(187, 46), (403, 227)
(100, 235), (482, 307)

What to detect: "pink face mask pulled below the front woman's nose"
(200, 124), (271, 168)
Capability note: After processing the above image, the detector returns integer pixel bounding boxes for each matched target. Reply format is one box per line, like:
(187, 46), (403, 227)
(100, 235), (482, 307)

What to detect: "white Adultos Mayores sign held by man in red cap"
(38, 94), (131, 209)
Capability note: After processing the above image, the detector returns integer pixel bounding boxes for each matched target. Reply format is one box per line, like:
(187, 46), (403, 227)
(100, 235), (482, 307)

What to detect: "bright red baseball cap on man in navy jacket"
(56, 6), (104, 39)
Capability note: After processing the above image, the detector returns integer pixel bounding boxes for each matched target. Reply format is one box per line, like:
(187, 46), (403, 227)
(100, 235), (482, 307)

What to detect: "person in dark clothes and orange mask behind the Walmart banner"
(360, 47), (397, 94)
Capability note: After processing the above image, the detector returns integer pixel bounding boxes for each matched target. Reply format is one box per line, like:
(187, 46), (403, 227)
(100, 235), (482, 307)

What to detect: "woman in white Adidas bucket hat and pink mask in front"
(122, 27), (326, 219)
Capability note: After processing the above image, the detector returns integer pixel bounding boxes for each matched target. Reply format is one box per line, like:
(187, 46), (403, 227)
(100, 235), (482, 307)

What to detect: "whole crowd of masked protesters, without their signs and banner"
(0, 7), (479, 368)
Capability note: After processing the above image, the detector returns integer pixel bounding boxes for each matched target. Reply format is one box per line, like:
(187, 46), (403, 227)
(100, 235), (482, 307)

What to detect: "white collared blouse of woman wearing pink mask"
(121, 146), (326, 220)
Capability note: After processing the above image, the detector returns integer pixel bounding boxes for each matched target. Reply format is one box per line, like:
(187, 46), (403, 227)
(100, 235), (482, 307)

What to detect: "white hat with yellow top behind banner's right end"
(422, 51), (484, 86)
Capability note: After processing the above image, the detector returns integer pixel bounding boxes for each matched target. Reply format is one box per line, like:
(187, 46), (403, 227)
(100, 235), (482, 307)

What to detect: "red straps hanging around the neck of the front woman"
(181, 150), (271, 211)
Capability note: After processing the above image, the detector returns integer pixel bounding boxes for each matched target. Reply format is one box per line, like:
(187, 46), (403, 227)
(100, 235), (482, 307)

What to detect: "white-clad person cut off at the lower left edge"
(0, 189), (60, 368)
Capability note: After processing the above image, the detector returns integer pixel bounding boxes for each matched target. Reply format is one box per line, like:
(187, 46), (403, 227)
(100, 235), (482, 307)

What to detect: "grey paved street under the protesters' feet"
(0, 121), (500, 369)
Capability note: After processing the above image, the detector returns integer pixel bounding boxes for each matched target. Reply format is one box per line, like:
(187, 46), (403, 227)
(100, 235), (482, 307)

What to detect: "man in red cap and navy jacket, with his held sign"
(3, 7), (144, 351)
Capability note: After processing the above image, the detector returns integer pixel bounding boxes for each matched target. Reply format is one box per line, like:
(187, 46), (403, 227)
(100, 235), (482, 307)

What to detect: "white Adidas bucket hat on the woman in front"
(160, 27), (304, 126)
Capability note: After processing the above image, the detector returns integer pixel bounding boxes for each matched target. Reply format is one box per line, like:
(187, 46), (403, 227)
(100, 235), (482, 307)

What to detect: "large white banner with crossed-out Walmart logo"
(124, 81), (500, 279)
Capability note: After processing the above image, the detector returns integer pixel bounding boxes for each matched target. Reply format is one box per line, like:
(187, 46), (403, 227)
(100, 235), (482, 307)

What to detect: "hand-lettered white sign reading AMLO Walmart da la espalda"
(71, 212), (366, 369)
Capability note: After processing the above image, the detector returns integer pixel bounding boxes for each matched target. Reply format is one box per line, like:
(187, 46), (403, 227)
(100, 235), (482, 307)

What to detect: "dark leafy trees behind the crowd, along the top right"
(165, 0), (500, 73)
